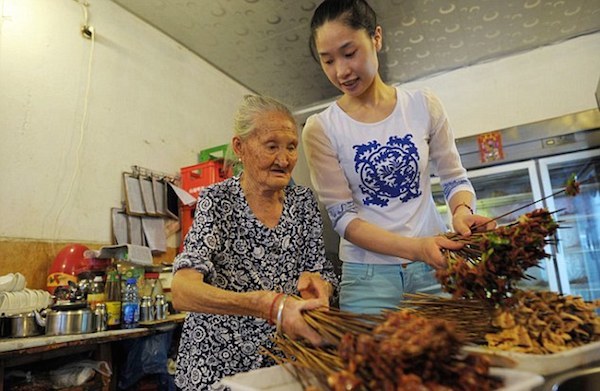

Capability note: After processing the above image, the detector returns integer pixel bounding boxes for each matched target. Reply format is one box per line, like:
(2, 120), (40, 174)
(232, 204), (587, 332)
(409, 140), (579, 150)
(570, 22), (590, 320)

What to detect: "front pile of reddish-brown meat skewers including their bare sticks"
(276, 310), (502, 391)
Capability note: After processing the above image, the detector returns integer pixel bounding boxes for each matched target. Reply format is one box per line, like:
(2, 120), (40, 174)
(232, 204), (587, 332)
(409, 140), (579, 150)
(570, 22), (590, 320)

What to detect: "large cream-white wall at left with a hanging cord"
(0, 0), (249, 242)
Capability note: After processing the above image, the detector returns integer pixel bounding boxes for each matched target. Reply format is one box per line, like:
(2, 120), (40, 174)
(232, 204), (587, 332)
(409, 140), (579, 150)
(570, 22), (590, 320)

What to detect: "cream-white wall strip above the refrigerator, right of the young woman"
(405, 33), (600, 137)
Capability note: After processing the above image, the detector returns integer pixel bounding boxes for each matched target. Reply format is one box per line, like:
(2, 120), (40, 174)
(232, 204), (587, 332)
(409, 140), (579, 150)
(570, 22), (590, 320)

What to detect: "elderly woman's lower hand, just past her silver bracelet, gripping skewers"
(277, 296), (323, 346)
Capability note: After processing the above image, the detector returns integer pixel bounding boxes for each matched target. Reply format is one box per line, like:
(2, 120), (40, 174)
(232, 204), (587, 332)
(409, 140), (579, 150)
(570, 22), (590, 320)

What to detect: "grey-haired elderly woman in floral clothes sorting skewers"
(171, 95), (335, 390)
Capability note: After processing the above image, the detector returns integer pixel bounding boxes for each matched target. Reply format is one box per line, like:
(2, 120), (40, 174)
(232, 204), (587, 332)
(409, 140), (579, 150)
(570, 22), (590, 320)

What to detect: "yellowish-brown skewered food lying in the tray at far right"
(400, 290), (600, 354)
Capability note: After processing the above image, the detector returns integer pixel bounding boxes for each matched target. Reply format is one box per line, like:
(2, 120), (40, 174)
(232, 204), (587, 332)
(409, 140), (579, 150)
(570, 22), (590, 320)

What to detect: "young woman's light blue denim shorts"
(340, 262), (441, 314)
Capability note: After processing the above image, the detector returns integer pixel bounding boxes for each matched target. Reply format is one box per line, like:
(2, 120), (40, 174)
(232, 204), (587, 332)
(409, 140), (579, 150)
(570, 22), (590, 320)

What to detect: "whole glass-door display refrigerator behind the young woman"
(432, 110), (600, 300)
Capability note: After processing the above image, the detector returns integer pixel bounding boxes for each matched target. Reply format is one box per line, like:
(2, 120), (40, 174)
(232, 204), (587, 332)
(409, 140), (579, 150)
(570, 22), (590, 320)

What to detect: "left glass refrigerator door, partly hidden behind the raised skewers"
(432, 160), (559, 290)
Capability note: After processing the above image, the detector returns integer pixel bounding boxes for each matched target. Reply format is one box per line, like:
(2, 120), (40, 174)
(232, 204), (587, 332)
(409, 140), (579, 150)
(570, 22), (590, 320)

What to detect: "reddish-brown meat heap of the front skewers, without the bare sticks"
(328, 311), (501, 390)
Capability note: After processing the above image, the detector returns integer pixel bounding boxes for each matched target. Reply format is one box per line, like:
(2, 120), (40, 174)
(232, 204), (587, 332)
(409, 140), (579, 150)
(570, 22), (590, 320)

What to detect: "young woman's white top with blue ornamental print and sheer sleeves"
(302, 88), (475, 264)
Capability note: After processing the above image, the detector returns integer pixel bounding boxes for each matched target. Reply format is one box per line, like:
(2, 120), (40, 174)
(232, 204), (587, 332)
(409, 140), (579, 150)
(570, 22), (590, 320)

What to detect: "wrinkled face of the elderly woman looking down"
(240, 111), (298, 190)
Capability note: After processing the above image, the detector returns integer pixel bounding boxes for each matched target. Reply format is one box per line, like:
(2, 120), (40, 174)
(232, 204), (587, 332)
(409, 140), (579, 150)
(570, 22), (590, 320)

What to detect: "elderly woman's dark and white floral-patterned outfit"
(173, 177), (337, 391)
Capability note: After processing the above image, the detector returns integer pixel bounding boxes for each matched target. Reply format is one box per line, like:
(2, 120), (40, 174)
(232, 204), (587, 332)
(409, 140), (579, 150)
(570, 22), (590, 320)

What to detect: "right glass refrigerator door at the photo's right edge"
(539, 149), (600, 300)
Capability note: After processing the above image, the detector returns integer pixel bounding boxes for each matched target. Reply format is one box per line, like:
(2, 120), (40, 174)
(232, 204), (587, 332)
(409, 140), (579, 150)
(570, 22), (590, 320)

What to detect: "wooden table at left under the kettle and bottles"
(0, 314), (185, 391)
